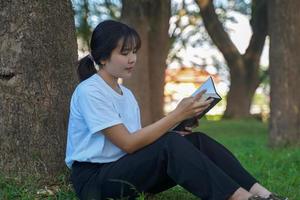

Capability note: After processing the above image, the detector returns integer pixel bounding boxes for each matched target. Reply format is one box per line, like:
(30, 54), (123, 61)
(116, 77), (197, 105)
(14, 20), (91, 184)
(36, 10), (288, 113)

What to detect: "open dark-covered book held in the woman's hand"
(172, 77), (222, 131)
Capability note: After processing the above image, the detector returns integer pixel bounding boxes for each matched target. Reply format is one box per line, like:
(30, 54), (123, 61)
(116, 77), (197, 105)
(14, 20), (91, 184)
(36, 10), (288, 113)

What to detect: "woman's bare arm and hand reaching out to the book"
(103, 90), (211, 153)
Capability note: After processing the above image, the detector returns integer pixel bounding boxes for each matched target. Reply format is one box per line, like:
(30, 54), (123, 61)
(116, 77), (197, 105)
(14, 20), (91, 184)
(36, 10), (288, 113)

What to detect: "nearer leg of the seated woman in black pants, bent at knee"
(73, 133), (240, 200)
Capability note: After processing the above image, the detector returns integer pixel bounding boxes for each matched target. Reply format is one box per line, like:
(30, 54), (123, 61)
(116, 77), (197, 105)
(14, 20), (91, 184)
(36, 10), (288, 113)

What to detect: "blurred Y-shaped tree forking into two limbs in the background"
(195, 0), (268, 118)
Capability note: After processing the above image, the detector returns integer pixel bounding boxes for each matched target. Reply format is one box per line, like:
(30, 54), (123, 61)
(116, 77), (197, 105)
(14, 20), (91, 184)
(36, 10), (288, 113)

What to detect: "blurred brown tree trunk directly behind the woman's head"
(121, 0), (171, 126)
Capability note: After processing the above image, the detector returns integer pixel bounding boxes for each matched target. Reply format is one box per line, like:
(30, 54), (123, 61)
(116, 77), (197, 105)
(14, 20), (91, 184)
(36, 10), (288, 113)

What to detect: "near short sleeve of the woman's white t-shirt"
(78, 88), (122, 133)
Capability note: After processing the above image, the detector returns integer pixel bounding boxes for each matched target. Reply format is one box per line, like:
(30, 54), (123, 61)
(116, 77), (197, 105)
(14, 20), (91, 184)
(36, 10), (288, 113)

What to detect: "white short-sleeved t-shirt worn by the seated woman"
(65, 74), (141, 168)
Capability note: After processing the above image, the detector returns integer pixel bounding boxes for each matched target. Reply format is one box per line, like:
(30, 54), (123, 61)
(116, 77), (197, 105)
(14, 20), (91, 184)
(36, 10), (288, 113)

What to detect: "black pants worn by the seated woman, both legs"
(71, 132), (257, 200)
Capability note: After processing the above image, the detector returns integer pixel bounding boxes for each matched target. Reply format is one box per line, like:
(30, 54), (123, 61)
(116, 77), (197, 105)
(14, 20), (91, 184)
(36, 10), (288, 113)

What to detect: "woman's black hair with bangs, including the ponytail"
(77, 20), (141, 81)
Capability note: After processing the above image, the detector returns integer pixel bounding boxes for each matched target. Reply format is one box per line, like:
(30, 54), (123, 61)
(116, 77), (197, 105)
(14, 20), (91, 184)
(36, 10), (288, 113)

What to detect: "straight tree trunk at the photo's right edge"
(268, 0), (300, 146)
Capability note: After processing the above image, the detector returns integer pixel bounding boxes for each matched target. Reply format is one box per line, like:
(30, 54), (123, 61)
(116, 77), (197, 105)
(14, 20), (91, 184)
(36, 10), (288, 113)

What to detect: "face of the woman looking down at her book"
(103, 41), (137, 78)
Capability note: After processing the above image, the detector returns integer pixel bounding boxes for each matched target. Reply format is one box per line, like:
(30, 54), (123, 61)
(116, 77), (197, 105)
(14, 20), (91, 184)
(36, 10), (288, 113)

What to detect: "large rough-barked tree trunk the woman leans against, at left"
(0, 1), (77, 180)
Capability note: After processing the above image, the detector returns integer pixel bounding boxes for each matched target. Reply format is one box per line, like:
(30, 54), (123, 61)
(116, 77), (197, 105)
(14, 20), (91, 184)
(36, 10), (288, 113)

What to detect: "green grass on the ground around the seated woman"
(0, 120), (300, 200)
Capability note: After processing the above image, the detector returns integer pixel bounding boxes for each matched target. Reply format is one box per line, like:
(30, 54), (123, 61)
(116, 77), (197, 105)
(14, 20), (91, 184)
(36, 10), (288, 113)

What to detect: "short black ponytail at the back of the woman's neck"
(77, 55), (97, 82)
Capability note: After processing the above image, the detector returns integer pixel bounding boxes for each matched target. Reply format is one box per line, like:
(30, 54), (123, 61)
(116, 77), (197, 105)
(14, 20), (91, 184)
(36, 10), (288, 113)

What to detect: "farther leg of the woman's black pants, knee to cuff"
(184, 132), (257, 191)
